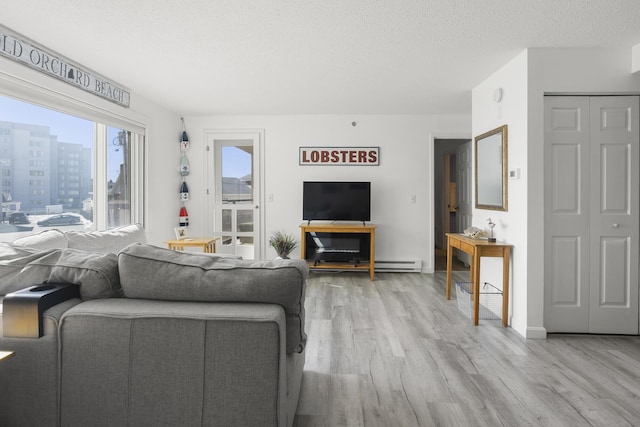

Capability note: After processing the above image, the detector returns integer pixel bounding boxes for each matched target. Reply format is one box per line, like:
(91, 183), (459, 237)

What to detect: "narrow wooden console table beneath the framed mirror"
(447, 233), (512, 326)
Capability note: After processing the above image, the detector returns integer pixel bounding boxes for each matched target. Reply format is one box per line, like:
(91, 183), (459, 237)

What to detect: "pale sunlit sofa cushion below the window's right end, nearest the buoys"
(65, 224), (147, 253)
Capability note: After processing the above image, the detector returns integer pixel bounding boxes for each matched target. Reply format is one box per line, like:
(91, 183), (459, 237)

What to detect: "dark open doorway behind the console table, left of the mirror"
(433, 138), (472, 271)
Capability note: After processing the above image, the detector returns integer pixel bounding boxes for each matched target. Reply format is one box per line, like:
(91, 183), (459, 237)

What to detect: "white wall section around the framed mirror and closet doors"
(472, 49), (640, 338)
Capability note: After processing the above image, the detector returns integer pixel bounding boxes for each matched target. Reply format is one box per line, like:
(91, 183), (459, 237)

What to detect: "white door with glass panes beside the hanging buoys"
(207, 131), (263, 259)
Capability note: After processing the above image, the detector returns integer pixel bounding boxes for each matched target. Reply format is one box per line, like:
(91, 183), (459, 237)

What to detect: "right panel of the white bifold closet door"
(589, 96), (640, 334)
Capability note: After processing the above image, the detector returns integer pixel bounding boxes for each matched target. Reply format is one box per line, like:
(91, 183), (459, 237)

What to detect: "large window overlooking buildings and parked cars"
(0, 95), (144, 241)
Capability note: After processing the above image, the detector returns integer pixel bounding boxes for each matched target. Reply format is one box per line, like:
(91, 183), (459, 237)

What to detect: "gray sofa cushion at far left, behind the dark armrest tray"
(0, 249), (122, 300)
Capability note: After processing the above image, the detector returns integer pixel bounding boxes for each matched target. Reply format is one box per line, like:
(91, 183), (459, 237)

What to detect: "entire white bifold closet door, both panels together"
(544, 96), (640, 334)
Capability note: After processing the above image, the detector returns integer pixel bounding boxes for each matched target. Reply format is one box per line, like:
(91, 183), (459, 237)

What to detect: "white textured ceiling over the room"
(0, 0), (640, 115)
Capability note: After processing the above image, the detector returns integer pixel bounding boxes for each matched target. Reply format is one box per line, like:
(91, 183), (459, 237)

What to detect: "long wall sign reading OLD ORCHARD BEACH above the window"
(0, 25), (130, 108)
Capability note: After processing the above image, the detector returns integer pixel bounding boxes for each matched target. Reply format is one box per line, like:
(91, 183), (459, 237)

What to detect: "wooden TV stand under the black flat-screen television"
(300, 223), (376, 280)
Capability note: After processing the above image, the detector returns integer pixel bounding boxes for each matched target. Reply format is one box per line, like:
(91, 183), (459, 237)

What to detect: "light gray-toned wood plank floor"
(294, 272), (640, 427)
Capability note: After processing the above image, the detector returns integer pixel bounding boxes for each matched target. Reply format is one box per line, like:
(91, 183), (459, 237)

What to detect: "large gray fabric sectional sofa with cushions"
(0, 226), (308, 427)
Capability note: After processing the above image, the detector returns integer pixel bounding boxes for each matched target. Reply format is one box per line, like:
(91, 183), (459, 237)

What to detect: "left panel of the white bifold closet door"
(544, 97), (590, 332)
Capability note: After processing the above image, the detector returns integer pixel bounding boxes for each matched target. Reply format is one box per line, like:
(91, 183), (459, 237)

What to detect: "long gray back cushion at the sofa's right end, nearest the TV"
(118, 245), (309, 353)
